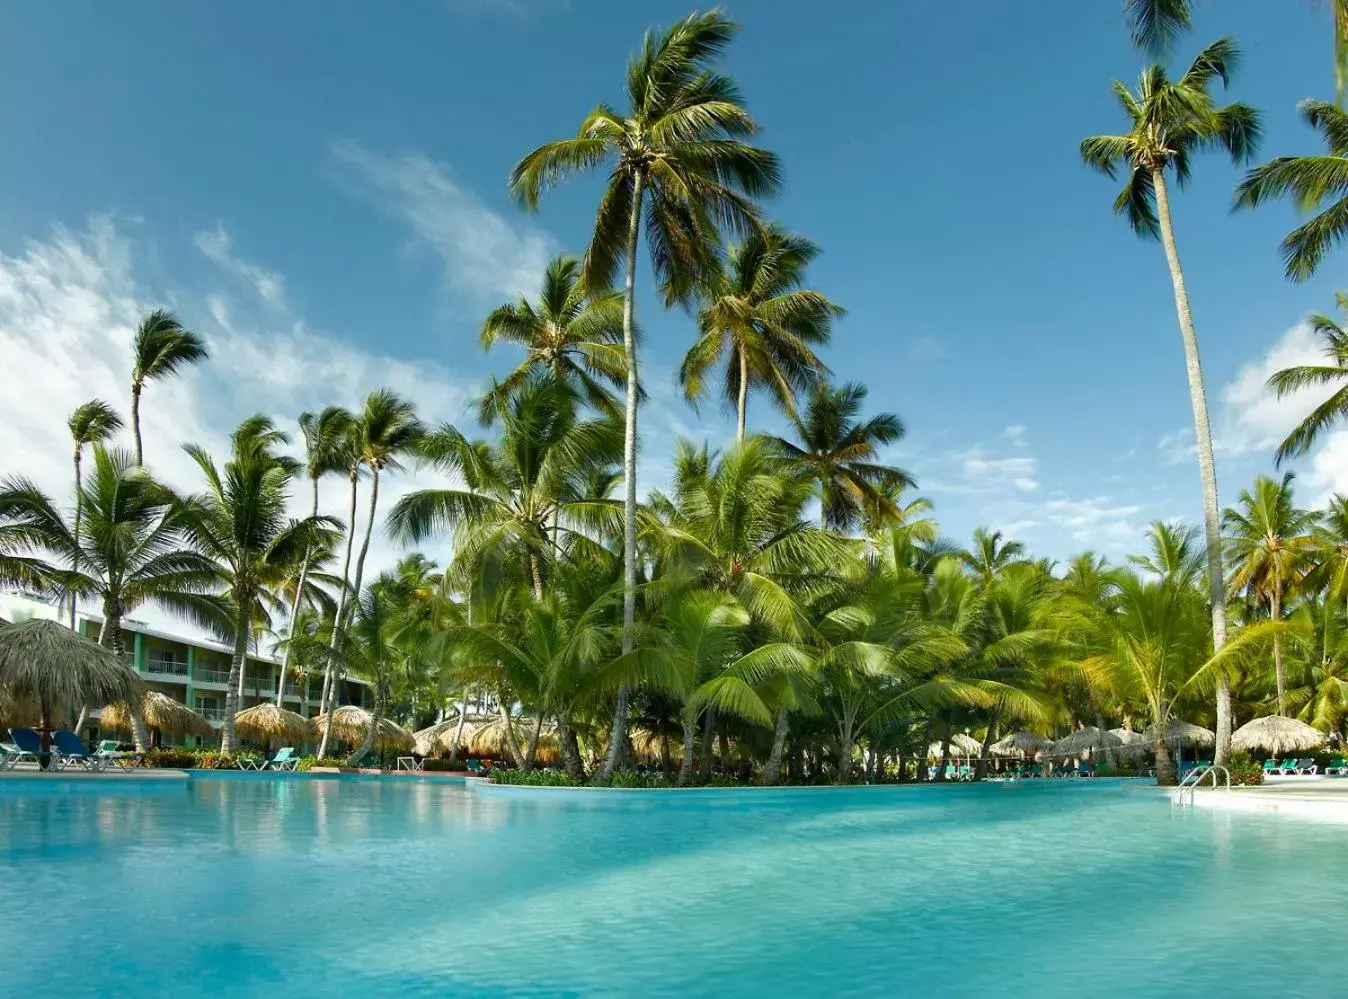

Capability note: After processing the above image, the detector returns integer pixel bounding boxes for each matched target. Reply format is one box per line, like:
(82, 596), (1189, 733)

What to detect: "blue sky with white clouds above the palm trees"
(0, 0), (1348, 577)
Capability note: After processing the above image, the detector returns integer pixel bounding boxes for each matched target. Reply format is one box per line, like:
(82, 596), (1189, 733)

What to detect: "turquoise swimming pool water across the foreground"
(0, 775), (1348, 999)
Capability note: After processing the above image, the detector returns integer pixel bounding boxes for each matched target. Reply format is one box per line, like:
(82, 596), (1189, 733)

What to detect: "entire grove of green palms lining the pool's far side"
(0, 0), (1348, 786)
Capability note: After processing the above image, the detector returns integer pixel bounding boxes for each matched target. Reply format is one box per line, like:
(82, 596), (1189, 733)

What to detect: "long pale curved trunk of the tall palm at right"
(1151, 169), (1231, 763)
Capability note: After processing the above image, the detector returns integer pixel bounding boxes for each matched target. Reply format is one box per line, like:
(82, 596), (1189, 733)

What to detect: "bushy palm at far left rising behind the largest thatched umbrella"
(0, 444), (228, 751)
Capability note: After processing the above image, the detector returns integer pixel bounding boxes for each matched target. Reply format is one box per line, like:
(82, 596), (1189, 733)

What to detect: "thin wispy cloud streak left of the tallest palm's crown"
(333, 142), (555, 297)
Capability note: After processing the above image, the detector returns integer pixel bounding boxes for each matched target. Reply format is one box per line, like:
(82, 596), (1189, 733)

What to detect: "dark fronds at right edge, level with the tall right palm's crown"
(1236, 101), (1348, 282)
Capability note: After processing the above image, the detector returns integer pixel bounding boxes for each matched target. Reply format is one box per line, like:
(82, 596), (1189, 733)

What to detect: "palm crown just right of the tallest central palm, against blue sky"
(679, 224), (843, 441)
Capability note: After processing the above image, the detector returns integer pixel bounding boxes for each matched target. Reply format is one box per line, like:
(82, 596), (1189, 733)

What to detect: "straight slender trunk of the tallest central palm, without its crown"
(599, 171), (646, 779)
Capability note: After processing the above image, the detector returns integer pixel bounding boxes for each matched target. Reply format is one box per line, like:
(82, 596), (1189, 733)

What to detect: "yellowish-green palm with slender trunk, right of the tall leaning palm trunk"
(1223, 472), (1316, 715)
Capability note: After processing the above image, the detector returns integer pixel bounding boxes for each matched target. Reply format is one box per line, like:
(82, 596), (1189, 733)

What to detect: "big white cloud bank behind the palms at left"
(0, 218), (474, 639)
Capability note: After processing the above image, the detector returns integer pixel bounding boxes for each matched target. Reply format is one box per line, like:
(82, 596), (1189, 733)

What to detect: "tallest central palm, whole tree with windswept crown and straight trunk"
(510, 11), (779, 778)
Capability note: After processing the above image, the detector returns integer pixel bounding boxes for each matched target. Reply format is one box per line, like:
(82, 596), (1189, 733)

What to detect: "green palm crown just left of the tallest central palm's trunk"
(479, 255), (627, 426)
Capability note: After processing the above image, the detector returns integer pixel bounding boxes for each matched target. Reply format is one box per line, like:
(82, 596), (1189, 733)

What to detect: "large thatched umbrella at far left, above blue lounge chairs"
(0, 619), (143, 750)
